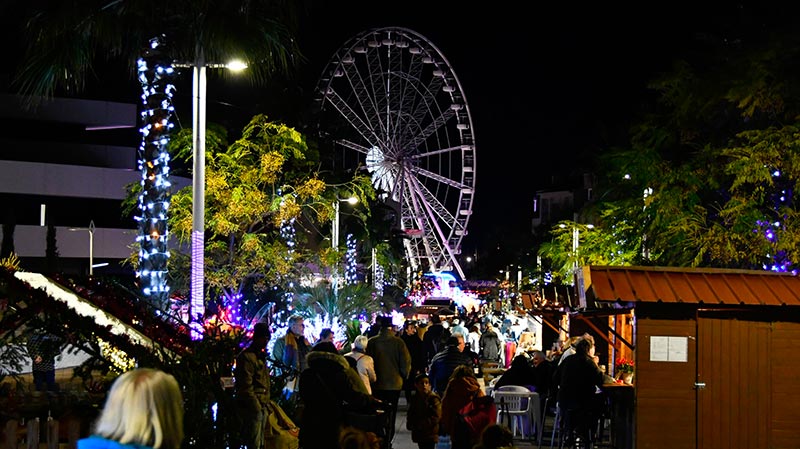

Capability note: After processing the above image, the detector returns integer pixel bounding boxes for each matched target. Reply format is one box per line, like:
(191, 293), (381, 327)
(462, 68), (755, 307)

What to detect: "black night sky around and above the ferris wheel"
(6, 0), (798, 270)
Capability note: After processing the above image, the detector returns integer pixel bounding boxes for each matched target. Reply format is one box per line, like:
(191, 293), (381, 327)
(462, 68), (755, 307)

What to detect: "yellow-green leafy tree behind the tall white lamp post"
(169, 115), (374, 306)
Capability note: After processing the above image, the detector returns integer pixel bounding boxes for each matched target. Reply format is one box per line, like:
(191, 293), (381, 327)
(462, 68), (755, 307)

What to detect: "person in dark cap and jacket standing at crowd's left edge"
(235, 323), (270, 449)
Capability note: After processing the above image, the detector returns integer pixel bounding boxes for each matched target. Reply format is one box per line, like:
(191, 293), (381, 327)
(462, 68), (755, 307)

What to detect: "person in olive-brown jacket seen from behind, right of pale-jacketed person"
(367, 316), (411, 447)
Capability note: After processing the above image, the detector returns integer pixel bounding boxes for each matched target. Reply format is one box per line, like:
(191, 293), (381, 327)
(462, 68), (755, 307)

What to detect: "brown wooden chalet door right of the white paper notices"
(696, 316), (771, 449)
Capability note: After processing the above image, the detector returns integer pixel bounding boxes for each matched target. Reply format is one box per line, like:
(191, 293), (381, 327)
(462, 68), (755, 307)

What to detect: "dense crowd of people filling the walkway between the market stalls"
(266, 311), (546, 449)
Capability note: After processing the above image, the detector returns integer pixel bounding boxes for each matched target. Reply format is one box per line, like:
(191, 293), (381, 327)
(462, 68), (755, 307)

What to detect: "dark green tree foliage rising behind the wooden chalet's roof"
(540, 29), (800, 275)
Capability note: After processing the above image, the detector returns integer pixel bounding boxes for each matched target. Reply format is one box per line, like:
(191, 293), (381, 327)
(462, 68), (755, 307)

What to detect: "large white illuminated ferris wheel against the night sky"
(317, 28), (475, 279)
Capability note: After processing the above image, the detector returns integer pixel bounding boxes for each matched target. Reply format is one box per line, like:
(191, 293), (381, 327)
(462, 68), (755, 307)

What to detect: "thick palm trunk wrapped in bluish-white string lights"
(135, 38), (175, 303)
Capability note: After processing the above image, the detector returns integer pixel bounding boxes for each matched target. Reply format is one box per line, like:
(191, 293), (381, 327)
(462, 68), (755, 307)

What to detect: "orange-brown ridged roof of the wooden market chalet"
(582, 266), (800, 306)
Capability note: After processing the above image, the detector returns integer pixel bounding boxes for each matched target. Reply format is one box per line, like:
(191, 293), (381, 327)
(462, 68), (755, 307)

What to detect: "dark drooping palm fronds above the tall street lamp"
(16, 0), (302, 104)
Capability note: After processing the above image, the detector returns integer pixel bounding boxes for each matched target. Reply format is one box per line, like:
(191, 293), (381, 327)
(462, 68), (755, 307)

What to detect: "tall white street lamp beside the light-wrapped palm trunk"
(173, 58), (247, 321)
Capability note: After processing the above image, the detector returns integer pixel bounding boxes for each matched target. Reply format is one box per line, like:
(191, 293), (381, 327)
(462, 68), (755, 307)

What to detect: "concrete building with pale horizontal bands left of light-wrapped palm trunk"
(0, 94), (191, 273)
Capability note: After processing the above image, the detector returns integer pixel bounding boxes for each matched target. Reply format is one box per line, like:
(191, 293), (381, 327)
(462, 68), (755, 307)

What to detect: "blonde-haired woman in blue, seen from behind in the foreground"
(78, 368), (183, 449)
